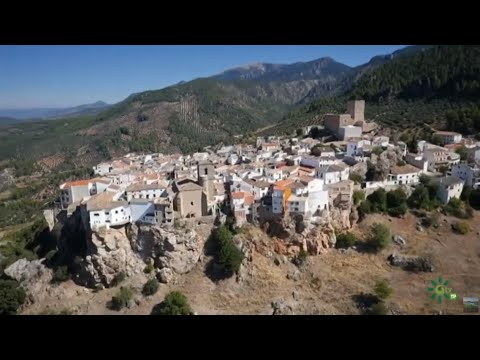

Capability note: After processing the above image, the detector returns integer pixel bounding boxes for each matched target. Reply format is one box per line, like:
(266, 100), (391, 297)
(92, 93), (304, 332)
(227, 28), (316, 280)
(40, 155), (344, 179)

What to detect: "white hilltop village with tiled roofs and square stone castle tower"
(60, 101), (480, 230)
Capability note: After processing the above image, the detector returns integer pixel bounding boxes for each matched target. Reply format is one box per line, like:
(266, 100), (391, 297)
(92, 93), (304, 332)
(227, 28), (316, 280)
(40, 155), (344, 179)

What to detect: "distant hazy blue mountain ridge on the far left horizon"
(0, 101), (111, 123)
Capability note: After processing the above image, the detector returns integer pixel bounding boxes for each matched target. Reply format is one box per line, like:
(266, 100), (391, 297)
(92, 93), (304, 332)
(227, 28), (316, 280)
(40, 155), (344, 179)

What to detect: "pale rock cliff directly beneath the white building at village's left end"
(73, 229), (145, 287)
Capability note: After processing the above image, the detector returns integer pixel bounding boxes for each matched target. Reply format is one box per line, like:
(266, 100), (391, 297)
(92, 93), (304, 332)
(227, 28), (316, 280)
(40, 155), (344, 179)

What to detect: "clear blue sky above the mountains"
(0, 45), (405, 108)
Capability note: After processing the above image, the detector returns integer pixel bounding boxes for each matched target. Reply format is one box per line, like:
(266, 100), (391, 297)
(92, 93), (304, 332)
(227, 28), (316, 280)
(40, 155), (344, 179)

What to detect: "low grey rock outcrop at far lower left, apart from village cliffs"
(5, 259), (53, 304)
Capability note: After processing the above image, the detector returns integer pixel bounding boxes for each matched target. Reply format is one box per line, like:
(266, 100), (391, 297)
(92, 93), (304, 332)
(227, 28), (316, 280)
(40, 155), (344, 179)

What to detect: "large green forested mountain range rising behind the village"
(0, 45), (478, 171)
